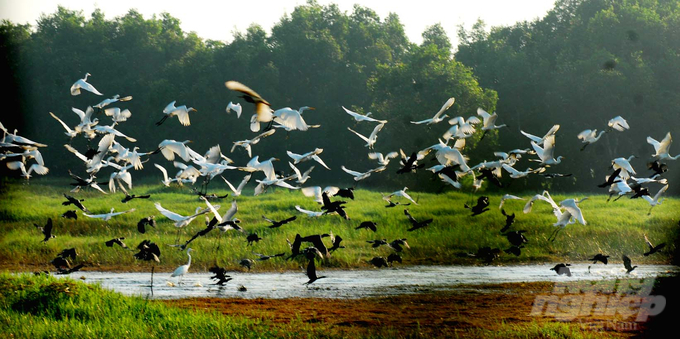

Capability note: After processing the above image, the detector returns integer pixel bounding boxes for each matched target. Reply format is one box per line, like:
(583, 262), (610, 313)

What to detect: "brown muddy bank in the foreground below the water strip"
(162, 277), (680, 337)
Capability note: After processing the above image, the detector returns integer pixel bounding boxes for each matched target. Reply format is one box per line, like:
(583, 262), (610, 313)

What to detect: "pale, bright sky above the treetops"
(0, 0), (554, 46)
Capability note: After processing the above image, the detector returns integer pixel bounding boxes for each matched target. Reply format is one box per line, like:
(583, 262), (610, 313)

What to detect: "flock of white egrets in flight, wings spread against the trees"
(0, 73), (680, 284)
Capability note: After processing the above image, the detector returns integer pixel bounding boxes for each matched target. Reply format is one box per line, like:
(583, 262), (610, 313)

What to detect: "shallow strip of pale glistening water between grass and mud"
(57, 264), (680, 299)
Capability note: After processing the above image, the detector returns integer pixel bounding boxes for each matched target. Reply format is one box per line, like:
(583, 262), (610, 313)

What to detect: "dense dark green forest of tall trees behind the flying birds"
(0, 0), (680, 193)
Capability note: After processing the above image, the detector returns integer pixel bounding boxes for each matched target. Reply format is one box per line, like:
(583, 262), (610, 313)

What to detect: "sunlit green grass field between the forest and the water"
(0, 180), (680, 272)
